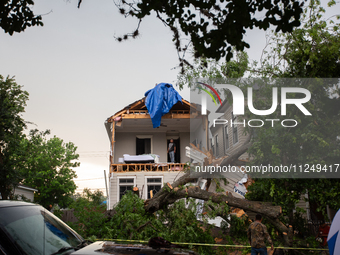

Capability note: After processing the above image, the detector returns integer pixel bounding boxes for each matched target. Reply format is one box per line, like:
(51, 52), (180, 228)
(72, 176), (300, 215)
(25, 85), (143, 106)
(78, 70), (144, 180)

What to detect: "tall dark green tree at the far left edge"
(0, 75), (28, 199)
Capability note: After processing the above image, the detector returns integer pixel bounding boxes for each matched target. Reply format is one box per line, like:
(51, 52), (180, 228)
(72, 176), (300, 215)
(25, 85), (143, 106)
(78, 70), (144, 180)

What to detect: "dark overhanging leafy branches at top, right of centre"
(113, 0), (304, 66)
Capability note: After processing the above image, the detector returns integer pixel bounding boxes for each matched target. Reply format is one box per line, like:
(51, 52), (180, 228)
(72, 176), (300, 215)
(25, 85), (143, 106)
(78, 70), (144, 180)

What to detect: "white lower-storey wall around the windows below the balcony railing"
(109, 171), (184, 209)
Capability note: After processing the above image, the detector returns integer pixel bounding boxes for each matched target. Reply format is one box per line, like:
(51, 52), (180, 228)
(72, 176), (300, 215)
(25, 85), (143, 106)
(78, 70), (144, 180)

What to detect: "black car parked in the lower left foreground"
(0, 200), (198, 255)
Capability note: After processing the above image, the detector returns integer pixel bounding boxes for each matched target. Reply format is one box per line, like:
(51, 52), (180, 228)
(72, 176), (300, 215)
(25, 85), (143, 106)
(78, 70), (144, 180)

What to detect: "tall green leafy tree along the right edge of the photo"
(248, 1), (340, 224)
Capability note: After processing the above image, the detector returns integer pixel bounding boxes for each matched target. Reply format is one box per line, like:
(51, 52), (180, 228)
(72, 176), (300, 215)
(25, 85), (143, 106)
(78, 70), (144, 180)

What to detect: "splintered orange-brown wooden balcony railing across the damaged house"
(110, 163), (186, 173)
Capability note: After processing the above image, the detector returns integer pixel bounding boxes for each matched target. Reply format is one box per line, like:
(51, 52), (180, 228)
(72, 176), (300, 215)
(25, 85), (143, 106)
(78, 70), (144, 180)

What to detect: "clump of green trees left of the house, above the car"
(0, 75), (80, 208)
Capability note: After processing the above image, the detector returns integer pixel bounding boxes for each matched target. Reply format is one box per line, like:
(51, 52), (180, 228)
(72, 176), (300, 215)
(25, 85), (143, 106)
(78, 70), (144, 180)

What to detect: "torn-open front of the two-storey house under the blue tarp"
(105, 86), (208, 209)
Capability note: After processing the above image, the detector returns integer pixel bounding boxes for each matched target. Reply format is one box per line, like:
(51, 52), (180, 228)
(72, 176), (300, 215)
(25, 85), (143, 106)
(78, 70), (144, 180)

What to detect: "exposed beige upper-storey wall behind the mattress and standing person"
(114, 132), (190, 163)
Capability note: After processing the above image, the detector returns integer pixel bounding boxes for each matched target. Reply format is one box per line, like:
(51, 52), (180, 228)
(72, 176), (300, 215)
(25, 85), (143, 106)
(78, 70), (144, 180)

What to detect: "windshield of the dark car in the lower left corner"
(0, 206), (82, 255)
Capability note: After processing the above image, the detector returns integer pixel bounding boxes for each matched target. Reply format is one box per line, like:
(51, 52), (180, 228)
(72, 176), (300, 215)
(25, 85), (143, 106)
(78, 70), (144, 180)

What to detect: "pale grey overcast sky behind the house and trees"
(0, 0), (274, 193)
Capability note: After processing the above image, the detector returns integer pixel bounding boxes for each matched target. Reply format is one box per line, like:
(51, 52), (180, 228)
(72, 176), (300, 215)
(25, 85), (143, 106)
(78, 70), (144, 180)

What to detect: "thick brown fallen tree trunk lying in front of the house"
(144, 138), (293, 246)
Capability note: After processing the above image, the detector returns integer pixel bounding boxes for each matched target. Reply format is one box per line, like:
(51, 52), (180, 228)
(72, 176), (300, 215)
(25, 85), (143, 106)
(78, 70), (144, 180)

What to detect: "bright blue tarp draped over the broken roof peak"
(145, 83), (182, 128)
